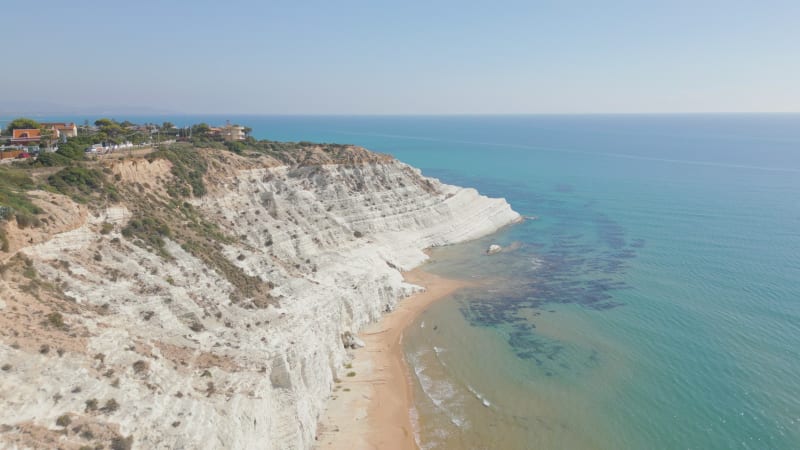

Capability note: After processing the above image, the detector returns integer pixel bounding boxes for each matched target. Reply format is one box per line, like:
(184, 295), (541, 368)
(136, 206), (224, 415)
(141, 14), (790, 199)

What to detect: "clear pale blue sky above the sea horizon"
(0, 0), (800, 114)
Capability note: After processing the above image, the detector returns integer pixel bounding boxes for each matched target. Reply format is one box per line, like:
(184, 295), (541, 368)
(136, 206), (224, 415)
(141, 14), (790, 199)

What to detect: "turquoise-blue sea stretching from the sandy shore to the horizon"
(10, 114), (800, 449)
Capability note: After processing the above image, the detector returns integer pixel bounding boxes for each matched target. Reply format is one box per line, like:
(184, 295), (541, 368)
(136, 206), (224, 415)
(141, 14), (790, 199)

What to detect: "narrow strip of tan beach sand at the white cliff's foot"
(315, 269), (470, 450)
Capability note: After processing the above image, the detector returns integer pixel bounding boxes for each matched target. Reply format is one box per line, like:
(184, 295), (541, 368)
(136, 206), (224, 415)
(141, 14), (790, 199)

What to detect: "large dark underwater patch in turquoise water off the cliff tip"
(422, 171), (645, 376)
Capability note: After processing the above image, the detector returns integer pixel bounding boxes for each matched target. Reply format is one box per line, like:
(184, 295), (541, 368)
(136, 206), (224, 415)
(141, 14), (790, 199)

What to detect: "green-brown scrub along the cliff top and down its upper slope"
(0, 128), (383, 307)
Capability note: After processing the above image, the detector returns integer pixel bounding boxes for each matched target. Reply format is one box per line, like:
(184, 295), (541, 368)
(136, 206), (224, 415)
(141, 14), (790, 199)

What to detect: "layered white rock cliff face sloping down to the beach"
(0, 150), (519, 449)
